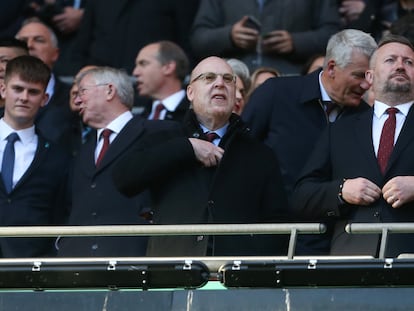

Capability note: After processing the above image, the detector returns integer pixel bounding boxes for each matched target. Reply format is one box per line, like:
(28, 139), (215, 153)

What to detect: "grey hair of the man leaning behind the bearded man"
(324, 29), (377, 68)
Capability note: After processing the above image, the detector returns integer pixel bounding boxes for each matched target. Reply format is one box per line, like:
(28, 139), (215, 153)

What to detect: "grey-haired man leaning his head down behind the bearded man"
(242, 29), (376, 255)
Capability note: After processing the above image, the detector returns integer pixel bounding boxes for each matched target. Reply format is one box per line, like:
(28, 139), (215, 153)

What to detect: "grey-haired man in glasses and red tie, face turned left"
(57, 67), (170, 257)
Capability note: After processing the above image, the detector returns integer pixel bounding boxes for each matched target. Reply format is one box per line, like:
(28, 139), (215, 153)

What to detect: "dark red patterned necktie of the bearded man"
(377, 108), (399, 174)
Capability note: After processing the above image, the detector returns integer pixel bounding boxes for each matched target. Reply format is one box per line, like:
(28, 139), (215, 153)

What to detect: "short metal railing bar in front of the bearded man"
(345, 222), (414, 234)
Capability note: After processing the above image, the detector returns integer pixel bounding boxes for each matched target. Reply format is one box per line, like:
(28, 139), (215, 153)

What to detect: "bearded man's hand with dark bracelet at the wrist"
(342, 177), (381, 205)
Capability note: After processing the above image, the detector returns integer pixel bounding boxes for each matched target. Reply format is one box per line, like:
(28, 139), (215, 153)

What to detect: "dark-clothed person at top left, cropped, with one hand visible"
(21, 0), (87, 75)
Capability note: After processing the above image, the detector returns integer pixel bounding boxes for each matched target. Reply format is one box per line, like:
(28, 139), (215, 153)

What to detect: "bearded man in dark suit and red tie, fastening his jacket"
(294, 36), (414, 256)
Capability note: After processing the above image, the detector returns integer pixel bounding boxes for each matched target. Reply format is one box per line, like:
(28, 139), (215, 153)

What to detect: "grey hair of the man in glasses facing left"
(76, 67), (134, 109)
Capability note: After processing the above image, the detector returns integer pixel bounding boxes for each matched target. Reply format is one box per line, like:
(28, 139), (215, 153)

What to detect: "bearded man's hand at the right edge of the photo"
(382, 176), (414, 208)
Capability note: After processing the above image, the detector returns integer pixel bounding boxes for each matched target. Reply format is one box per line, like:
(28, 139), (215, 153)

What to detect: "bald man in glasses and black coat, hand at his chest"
(114, 57), (287, 256)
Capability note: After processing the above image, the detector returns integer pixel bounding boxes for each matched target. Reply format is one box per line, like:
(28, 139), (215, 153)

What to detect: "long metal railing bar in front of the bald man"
(0, 223), (326, 237)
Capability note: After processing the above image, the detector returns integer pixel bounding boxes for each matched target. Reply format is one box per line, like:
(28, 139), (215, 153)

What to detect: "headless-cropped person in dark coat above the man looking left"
(73, 0), (199, 74)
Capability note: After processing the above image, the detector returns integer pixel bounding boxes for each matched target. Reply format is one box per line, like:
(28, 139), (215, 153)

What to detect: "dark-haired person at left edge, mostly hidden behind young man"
(0, 38), (29, 117)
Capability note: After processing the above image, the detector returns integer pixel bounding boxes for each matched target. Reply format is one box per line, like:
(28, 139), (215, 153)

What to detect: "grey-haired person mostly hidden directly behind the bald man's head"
(227, 58), (250, 115)
